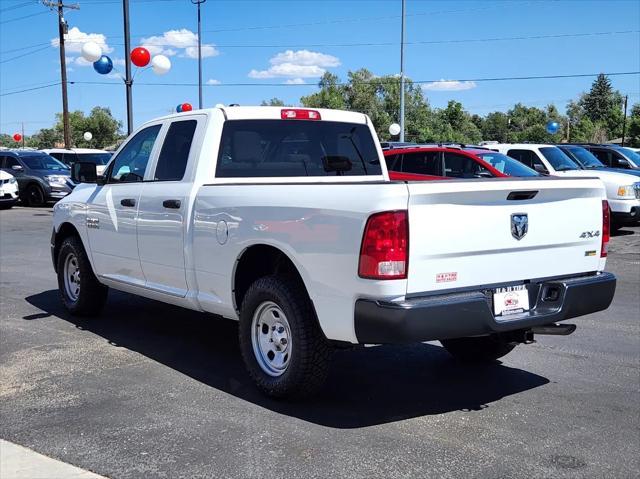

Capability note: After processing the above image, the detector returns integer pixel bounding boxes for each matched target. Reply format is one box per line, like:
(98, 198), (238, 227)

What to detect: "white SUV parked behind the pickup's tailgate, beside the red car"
(487, 143), (640, 227)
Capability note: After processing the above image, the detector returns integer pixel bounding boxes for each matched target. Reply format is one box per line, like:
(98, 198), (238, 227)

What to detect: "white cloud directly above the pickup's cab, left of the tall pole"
(249, 50), (340, 82)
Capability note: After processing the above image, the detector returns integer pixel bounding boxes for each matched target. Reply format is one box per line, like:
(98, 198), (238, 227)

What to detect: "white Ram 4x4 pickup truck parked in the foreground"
(51, 107), (616, 397)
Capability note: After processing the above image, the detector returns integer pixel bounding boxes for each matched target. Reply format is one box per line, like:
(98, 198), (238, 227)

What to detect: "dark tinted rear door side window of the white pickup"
(154, 120), (198, 181)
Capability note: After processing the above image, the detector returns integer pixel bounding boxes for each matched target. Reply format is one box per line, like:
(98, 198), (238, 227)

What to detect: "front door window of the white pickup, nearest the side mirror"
(109, 125), (162, 183)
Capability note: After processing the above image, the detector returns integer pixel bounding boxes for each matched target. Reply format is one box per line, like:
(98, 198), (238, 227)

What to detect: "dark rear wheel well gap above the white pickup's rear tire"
(233, 245), (308, 310)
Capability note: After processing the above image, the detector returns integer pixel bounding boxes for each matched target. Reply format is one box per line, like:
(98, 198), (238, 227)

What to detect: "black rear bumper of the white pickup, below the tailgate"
(355, 273), (616, 344)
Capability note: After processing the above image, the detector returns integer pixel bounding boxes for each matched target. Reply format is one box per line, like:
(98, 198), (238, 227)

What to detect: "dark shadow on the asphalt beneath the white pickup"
(24, 290), (549, 428)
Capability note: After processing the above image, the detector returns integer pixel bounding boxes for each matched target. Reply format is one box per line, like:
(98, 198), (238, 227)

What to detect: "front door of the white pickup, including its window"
(87, 124), (162, 286)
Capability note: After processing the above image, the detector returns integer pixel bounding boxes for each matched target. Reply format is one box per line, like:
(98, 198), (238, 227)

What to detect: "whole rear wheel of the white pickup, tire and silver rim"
(239, 276), (331, 398)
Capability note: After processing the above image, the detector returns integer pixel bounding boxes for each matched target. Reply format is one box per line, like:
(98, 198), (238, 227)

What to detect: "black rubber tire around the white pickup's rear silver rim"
(239, 276), (332, 399)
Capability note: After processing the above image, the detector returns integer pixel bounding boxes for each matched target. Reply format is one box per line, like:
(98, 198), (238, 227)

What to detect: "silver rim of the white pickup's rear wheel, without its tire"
(251, 301), (292, 377)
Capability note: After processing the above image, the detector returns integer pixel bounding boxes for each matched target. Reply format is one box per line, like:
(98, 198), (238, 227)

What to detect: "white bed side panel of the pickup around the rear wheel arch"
(192, 182), (408, 342)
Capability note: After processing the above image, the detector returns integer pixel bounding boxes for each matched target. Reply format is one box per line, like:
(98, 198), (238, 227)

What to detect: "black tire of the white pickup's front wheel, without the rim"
(57, 236), (109, 316)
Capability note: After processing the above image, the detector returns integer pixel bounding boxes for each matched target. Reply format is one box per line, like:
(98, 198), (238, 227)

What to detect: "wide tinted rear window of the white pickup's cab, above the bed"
(216, 120), (382, 178)
